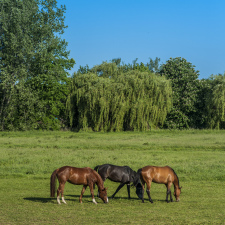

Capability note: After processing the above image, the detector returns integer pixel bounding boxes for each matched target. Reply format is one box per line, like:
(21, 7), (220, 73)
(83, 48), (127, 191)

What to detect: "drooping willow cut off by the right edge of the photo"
(206, 74), (225, 129)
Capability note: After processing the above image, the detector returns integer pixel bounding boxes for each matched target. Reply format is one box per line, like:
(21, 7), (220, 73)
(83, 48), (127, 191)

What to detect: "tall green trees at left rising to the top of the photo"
(0, 0), (75, 130)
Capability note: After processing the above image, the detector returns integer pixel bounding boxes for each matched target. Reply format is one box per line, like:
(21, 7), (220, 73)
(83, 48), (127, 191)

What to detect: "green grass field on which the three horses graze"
(0, 130), (225, 224)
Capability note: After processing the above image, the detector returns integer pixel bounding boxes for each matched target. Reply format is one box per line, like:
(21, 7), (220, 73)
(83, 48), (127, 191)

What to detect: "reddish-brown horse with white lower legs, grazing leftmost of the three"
(50, 166), (108, 204)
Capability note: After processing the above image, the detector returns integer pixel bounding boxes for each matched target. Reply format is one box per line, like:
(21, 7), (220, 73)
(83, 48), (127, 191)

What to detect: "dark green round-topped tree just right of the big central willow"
(160, 57), (199, 129)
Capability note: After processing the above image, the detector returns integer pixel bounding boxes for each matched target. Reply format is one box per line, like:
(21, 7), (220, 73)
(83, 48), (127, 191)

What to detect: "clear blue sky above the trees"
(57, 0), (225, 79)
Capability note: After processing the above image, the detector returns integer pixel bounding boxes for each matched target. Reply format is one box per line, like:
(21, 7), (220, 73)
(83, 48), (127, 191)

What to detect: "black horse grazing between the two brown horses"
(94, 164), (143, 199)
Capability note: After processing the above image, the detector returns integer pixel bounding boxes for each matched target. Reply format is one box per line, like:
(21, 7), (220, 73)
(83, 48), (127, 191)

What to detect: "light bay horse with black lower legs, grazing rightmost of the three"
(138, 166), (181, 203)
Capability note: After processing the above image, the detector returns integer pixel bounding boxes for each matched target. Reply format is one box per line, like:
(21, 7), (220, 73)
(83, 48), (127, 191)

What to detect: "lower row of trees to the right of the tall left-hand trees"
(67, 58), (225, 131)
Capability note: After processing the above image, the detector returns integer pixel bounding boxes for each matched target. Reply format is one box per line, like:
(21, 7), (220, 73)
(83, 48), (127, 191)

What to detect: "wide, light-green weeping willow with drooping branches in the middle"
(67, 65), (172, 131)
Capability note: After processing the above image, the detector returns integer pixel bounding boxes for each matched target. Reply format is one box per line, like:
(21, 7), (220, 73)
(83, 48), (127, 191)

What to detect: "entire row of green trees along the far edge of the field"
(0, 0), (225, 131)
